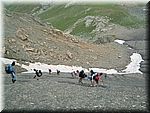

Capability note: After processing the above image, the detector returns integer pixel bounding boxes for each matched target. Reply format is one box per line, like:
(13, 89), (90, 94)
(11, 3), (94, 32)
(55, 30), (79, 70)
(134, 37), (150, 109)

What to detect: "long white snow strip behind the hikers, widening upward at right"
(0, 53), (144, 74)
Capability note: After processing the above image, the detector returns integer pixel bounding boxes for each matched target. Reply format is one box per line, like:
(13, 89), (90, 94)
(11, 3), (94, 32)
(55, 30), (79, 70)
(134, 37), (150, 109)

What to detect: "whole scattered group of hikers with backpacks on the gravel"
(5, 61), (103, 86)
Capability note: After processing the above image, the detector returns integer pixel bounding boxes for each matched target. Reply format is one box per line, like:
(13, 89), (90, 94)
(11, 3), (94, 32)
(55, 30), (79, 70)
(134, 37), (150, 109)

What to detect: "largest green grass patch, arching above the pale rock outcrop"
(38, 4), (143, 30)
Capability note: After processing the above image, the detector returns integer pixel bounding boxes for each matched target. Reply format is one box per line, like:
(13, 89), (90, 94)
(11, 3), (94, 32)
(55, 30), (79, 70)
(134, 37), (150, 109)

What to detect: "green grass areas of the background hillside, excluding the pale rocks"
(6, 4), (145, 37)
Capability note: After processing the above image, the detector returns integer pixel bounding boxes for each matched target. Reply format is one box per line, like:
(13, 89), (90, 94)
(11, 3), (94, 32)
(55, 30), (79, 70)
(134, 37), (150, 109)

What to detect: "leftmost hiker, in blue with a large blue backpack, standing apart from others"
(5, 61), (16, 83)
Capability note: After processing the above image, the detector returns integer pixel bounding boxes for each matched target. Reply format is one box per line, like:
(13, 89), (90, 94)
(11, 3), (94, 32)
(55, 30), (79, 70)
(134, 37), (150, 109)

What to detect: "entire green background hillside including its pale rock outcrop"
(6, 3), (146, 42)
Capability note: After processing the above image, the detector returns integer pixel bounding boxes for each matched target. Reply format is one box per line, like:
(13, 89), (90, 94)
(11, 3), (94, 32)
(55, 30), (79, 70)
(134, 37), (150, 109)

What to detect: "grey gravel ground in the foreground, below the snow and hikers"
(3, 73), (147, 112)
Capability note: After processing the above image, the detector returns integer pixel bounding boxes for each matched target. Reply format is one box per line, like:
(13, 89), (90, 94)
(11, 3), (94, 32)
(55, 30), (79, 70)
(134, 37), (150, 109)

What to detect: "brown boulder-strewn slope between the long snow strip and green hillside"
(4, 12), (131, 69)
